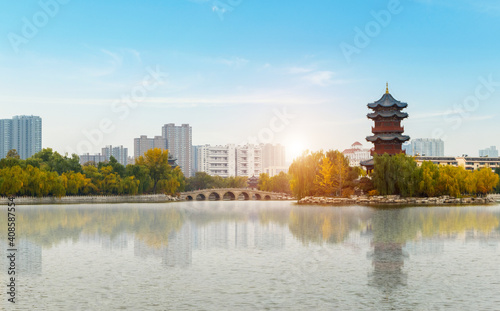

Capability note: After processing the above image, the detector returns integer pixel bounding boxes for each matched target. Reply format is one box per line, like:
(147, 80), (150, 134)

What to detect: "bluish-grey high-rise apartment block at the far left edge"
(0, 116), (42, 159)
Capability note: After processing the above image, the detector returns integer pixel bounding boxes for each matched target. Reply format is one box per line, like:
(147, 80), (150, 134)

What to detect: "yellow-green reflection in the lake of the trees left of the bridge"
(12, 207), (184, 248)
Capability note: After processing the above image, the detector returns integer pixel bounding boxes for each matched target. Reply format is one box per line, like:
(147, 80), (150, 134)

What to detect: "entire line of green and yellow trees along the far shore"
(0, 148), (500, 200)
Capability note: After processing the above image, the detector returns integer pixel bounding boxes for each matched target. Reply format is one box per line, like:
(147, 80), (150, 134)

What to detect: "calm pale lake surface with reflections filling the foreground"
(0, 201), (500, 310)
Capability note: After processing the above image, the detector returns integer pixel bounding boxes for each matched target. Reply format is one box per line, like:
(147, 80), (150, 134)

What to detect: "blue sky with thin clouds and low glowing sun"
(0, 0), (500, 161)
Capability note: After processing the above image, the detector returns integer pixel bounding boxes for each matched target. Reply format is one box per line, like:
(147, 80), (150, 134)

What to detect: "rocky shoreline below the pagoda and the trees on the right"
(297, 195), (499, 206)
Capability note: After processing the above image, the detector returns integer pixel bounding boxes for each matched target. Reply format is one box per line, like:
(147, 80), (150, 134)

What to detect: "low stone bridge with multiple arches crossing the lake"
(180, 188), (292, 201)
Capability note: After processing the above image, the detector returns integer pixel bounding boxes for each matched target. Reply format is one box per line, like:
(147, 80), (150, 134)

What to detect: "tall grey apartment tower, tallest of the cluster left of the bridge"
(161, 123), (192, 177)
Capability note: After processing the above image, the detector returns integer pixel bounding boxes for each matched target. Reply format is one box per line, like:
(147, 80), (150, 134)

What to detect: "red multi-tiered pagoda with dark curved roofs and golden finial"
(361, 84), (410, 171)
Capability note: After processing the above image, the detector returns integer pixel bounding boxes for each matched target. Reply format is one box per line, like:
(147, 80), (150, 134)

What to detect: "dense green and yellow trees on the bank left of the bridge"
(0, 148), (185, 197)
